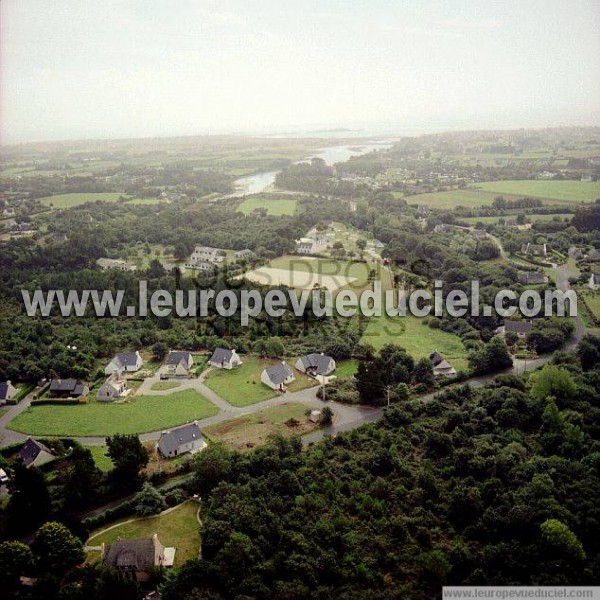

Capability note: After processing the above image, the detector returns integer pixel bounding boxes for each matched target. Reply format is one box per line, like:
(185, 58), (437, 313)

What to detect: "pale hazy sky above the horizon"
(0, 0), (600, 143)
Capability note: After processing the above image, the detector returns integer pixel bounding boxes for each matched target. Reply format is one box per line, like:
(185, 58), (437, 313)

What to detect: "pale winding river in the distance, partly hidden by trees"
(229, 140), (393, 198)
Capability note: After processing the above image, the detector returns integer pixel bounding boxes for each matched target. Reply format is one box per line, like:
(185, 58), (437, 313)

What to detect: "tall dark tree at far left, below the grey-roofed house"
(7, 462), (50, 533)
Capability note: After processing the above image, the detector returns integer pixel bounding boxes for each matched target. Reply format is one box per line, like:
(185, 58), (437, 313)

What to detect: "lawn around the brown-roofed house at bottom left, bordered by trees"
(87, 500), (200, 567)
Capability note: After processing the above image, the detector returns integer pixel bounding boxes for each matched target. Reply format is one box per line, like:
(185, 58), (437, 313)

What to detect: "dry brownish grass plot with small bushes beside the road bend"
(202, 402), (316, 450)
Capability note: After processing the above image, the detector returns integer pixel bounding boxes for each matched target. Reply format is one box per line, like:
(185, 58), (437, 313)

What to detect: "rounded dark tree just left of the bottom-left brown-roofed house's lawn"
(31, 521), (85, 574)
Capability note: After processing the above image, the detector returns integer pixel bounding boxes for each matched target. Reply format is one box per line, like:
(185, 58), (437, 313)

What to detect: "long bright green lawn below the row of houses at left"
(9, 389), (218, 436)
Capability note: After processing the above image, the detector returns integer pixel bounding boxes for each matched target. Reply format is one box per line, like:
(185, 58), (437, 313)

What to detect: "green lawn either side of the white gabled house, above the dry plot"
(205, 356), (315, 406)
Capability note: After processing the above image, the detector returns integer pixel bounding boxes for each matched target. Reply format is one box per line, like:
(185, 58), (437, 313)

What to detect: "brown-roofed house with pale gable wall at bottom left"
(101, 534), (175, 582)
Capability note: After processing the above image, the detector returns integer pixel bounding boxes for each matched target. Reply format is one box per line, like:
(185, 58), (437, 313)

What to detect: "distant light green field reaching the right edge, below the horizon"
(477, 180), (600, 203)
